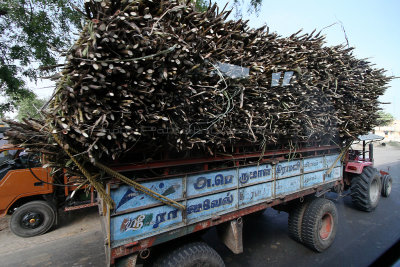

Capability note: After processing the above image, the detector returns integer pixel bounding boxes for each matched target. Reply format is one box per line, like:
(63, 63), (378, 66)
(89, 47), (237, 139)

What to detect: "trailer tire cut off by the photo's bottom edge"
(153, 242), (225, 267)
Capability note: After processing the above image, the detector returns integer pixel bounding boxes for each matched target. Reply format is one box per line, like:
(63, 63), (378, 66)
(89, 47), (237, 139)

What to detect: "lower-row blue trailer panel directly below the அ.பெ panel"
(187, 190), (238, 223)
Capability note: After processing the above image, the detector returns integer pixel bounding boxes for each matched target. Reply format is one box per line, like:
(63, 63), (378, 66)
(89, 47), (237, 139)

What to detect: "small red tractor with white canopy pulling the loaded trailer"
(344, 134), (392, 211)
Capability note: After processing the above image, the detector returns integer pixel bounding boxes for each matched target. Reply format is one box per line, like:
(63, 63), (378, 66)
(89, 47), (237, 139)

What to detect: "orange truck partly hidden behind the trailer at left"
(0, 144), (97, 237)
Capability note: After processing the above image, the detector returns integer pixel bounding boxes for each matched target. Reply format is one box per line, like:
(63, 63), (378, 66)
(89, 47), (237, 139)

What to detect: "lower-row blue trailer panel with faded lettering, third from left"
(239, 182), (274, 207)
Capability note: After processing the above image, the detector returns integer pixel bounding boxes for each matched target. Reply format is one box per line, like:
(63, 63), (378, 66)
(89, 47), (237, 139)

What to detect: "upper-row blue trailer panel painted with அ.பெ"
(187, 169), (238, 197)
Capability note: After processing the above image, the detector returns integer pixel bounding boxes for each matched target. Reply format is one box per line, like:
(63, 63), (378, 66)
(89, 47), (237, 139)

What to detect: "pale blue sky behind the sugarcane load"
(26, 0), (400, 119)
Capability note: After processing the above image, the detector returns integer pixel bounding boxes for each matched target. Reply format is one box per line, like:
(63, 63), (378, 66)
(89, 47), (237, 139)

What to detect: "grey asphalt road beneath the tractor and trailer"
(0, 147), (400, 267)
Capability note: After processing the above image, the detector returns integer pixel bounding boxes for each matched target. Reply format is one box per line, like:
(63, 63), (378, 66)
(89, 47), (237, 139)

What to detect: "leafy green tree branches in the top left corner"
(0, 0), (83, 115)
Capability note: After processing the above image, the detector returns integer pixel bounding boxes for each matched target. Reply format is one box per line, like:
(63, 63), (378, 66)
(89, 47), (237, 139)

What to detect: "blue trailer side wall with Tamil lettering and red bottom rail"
(103, 153), (343, 264)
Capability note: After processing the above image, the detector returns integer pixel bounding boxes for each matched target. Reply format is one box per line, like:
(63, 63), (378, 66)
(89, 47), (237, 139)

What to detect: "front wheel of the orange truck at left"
(10, 200), (56, 237)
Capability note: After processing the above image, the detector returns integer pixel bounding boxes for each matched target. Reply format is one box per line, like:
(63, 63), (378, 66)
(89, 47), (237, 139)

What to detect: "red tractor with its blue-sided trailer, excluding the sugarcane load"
(95, 135), (392, 266)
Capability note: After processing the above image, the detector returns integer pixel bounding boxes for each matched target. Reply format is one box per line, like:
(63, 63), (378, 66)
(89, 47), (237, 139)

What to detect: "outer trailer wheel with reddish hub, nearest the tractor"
(301, 198), (338, 252)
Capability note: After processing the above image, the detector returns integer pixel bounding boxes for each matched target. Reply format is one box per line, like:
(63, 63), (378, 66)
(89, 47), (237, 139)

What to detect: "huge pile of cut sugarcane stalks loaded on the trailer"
(3, 0), (391, 172)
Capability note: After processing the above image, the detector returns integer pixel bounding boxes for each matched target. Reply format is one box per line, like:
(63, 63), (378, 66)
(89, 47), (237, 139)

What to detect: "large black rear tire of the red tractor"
(350, 166), (381, 211)
